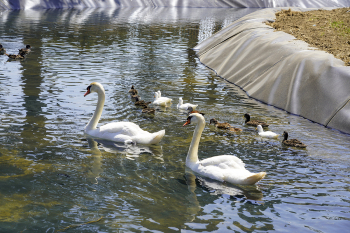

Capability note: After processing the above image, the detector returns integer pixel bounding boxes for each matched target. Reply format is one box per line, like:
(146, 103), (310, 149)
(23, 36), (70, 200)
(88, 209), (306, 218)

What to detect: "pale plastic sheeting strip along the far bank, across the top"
(0, 0), (350, 10)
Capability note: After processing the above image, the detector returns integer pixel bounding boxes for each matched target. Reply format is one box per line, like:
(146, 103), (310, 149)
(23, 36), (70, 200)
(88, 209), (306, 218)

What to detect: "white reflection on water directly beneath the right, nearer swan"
(186, 169), (263, 201)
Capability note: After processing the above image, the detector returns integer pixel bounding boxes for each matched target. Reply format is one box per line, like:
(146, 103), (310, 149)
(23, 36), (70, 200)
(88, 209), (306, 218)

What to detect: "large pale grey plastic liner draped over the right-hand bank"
(195, 8), (350, 133)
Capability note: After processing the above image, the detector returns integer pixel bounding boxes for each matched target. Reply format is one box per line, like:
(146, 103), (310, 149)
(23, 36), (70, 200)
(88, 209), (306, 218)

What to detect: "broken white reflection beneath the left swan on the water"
(94, 139), (163, 161)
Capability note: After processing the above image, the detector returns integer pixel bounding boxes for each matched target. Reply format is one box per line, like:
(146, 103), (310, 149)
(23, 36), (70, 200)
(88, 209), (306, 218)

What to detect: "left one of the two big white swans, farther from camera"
(84, 82), (165, 144)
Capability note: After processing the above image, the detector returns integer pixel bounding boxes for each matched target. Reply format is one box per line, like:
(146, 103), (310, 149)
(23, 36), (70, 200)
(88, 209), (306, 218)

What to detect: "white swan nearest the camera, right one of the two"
(183, 113), (266, 185)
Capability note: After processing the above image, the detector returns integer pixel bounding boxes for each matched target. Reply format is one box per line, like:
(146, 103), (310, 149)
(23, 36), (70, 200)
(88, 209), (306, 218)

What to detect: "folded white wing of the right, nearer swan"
(200, 155), (245, 169)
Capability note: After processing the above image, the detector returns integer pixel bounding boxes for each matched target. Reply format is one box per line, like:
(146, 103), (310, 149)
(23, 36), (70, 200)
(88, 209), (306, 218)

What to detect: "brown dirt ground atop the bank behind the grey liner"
(266, 7), (350, 66)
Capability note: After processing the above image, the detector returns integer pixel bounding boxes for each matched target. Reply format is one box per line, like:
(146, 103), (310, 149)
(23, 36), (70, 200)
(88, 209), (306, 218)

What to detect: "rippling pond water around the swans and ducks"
(0, 8), (350, 232)
